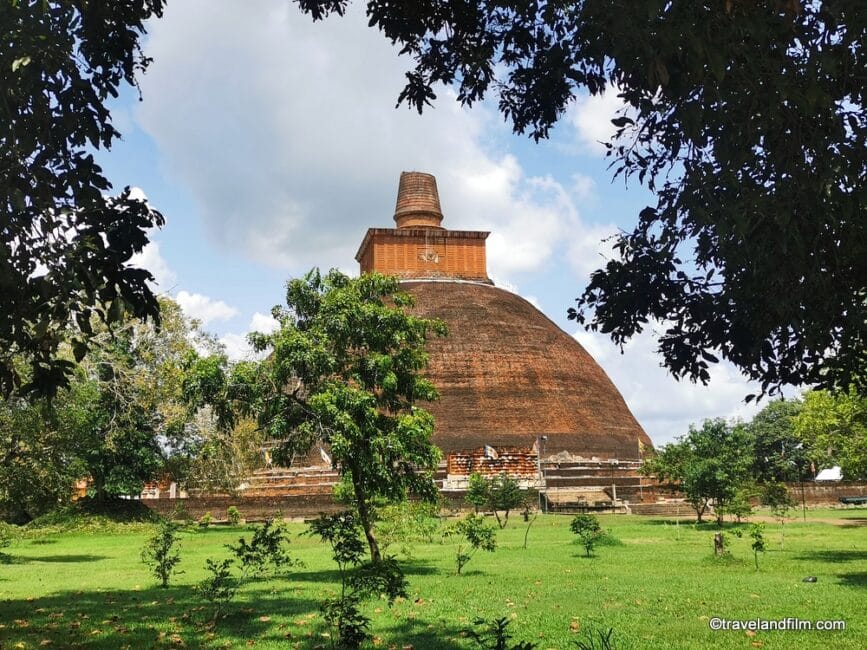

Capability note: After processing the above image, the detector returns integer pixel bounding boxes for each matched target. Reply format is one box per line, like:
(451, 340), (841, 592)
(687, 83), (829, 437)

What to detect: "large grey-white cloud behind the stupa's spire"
(137, 0), (590, 286)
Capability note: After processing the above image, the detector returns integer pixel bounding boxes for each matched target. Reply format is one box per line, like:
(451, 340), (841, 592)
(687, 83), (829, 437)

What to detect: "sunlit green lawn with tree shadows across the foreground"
(0, 509), (867, 650)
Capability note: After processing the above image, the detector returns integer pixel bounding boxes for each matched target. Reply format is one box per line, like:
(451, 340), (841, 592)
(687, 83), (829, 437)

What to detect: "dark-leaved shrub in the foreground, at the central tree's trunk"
(307, 511), (407, 650)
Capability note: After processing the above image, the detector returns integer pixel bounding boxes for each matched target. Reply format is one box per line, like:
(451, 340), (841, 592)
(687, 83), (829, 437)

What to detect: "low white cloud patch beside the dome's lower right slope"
(574, 329), (761, 445)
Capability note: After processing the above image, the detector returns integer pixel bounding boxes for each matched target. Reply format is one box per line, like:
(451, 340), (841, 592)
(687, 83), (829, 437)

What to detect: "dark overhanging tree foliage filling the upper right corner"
(296, 0), (867, 393)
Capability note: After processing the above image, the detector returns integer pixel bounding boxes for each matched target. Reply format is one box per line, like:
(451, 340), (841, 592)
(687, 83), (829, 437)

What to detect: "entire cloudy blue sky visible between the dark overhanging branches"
(99, 0), (772, 444)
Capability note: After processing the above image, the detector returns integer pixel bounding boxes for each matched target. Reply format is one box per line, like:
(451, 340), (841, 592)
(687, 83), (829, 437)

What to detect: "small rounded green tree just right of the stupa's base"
(642, 418), (752, 525)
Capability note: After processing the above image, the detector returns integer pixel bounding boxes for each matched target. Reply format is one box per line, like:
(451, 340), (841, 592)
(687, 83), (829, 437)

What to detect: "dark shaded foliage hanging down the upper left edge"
(0, 0), (164, 397)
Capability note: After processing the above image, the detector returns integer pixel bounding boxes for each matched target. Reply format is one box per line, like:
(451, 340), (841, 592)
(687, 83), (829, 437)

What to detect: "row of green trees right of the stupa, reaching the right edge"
(642, 387), (867, 522)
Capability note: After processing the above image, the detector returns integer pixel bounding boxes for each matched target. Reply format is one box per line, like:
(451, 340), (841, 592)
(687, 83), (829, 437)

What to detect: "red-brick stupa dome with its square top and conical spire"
(355, 172), (651, 478)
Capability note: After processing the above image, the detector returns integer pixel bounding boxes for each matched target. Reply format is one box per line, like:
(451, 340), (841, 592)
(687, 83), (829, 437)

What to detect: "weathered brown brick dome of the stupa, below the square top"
(403, 281), (651, 460)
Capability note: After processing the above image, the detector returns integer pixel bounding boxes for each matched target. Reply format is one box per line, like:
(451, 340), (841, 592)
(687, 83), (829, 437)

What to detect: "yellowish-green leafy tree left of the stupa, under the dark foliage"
(54, 299), (211, 500)
